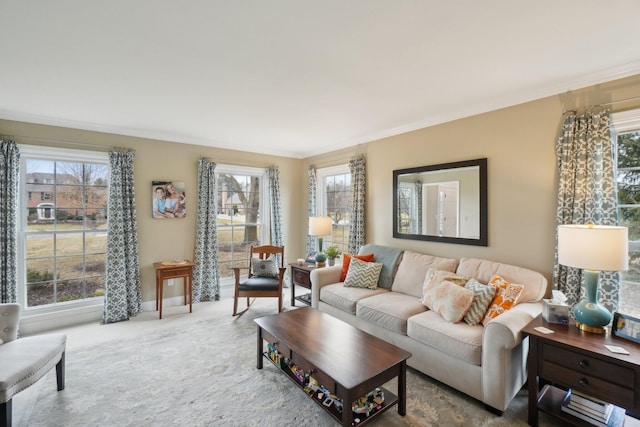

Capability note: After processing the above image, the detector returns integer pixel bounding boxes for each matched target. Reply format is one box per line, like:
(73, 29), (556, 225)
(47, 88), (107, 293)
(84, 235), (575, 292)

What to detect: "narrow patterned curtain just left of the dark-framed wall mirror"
(349, 157), (366, 254)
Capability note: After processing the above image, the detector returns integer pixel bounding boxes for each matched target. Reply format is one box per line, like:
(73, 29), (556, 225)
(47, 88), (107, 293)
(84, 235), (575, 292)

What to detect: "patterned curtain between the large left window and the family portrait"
(102, 151), (142, 323)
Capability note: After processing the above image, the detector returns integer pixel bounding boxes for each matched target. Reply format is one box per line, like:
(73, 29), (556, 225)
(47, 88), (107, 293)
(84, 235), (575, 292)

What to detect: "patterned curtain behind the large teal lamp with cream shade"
(553, 109), (619, 311)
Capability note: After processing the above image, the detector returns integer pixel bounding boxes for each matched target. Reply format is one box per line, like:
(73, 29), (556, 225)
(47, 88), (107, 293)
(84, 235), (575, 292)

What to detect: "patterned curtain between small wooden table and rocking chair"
(193, 159), (220, 302)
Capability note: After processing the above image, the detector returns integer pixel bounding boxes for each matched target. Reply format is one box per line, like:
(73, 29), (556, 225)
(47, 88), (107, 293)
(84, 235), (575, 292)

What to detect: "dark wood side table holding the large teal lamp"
(522, 316), (640, 426)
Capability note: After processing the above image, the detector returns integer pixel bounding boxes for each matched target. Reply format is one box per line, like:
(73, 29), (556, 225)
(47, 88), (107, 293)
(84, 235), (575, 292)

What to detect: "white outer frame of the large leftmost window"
(16, 144), (110, 317)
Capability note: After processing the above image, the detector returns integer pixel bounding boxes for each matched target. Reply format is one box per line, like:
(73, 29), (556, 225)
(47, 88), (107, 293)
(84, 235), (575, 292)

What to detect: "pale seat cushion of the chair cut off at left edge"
(0, 334), (67, 403)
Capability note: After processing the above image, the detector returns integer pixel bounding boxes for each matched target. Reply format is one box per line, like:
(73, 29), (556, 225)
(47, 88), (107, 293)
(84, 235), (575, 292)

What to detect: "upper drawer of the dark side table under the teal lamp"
(543, 344), (636, 389)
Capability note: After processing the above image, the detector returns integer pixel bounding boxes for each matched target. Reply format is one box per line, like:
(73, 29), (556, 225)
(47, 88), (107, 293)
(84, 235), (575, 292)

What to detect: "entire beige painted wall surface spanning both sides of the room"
(0, 75), (640, 301)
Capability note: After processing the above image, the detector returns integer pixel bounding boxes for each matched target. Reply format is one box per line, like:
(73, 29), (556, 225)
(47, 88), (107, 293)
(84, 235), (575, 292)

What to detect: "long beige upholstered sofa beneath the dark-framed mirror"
(311, 245), (547, 414)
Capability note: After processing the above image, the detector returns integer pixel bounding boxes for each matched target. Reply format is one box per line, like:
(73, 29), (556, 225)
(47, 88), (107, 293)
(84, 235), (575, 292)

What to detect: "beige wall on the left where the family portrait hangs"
(0, 120), (306, 301)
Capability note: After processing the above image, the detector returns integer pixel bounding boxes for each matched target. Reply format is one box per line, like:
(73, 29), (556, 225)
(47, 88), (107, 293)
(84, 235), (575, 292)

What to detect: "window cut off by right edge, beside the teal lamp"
(612, 110), (640, 317)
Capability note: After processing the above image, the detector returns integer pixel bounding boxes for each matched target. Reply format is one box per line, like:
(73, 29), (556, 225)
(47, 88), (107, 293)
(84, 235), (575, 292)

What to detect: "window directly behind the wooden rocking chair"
(216, 165), (270, 284)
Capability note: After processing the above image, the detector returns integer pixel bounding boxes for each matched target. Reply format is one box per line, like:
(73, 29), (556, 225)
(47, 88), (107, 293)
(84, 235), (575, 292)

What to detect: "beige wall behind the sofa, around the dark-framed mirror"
(305, 76), (640, 290)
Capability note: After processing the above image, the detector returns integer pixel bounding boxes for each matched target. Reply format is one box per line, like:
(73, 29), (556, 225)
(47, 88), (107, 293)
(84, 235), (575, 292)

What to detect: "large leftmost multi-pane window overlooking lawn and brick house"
(18, 146), (109, 311)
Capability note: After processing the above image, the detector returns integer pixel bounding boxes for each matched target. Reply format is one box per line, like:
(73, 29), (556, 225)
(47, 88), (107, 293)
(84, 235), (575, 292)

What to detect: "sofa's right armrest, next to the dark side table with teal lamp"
(482, 301), (542, 411)
